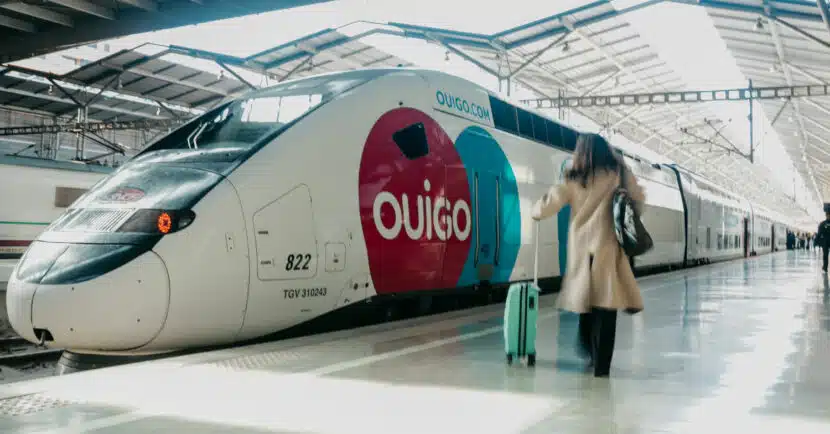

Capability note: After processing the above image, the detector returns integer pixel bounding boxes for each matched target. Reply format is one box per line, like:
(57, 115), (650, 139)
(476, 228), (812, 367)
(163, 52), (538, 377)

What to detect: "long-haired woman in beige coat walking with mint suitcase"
(533, 134), (645, 377)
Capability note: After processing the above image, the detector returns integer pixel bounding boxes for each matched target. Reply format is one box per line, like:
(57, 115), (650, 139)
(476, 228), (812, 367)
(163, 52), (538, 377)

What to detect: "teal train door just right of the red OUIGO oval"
(473, 171), (502, 281)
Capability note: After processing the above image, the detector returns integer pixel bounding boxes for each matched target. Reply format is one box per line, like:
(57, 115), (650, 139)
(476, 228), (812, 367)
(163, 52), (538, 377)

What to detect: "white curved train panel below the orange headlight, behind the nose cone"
(143, 180), (250, 350)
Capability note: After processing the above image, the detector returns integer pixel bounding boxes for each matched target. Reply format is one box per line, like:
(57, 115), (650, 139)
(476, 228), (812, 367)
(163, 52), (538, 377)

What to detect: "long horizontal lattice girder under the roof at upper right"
(521, 84), (830, 108)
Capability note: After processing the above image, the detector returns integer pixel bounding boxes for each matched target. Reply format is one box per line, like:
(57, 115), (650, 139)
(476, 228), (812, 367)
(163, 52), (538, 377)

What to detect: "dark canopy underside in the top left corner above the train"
(0, 0), (329, 63)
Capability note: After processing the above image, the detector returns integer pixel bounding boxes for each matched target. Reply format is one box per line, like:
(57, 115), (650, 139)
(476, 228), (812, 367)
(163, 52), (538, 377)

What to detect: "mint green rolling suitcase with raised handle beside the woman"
(503, 222), (540, 366)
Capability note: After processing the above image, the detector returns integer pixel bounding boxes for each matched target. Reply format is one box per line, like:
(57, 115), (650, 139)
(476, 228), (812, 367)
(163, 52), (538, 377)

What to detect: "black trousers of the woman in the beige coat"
(579, 307), (617, 377)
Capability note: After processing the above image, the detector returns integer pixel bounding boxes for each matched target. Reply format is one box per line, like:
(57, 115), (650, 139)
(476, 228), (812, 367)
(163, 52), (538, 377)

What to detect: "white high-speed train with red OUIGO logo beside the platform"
(6, 68), (796, 360)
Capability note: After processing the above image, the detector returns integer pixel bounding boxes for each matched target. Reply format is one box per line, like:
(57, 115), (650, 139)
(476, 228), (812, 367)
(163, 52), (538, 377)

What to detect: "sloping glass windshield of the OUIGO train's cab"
(142, 75), (369, 161)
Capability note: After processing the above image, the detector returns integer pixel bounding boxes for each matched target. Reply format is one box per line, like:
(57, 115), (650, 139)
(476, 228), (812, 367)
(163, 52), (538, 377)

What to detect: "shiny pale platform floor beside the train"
(0, 251), (830, 434)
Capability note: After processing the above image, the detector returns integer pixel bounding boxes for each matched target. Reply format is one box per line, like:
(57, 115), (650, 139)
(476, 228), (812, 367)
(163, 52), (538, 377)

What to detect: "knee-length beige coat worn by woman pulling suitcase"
(533, 170), (645, 313)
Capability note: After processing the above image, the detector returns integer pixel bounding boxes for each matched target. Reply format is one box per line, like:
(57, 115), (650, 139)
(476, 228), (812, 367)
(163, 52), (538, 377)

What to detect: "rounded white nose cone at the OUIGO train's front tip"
(6, 242), (170, 350)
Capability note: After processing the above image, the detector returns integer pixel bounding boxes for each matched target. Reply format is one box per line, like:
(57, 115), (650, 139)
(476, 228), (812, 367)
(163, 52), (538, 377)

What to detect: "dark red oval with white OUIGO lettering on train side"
(358, 107), (473, 293)
